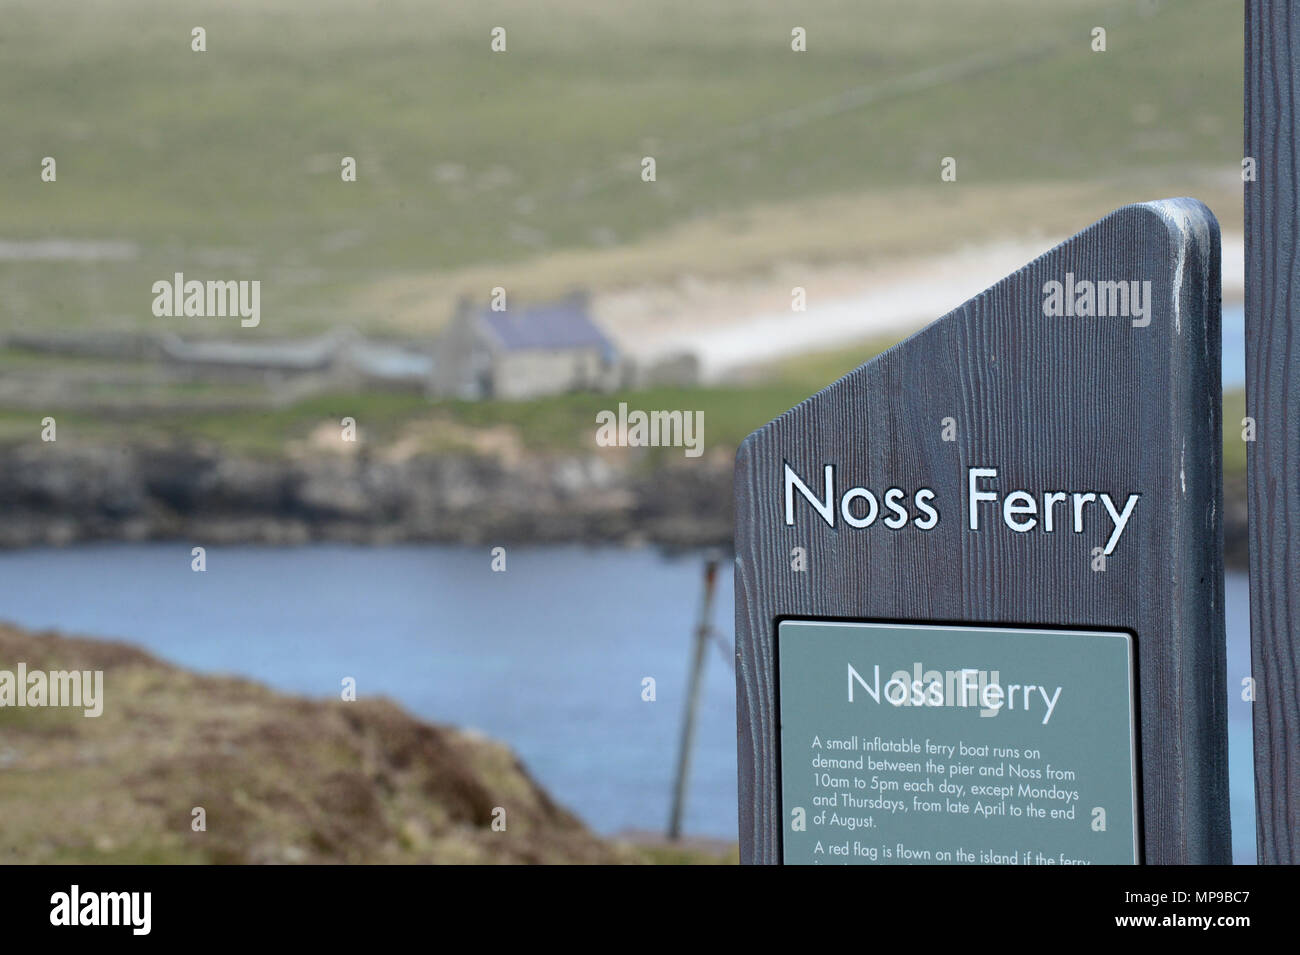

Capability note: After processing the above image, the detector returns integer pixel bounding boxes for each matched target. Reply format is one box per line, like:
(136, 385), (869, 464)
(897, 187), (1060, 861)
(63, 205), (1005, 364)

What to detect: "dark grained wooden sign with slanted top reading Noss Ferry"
(736, 199), (1231, 864)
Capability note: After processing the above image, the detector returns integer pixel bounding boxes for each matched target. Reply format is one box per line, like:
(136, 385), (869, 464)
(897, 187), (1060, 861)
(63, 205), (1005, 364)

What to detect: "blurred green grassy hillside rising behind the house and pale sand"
(0, 0), (1242, 338)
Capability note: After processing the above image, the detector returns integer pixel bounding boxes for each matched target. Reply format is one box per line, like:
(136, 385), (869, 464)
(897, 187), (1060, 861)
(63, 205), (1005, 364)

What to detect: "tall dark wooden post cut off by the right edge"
(1230, 0), (1300, 863)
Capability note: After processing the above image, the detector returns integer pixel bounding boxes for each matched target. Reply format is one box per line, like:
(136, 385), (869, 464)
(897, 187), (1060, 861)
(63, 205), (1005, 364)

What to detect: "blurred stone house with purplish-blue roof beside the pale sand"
(434, 295), (628, 399)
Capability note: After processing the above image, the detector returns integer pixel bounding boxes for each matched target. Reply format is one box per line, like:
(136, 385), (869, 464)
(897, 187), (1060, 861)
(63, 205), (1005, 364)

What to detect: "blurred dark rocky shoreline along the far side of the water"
(0, 443), (1247, 568)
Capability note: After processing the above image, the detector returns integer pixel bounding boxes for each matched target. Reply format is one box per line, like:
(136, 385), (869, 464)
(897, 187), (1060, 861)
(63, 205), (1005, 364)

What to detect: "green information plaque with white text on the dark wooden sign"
(776, 620), (1140, 865)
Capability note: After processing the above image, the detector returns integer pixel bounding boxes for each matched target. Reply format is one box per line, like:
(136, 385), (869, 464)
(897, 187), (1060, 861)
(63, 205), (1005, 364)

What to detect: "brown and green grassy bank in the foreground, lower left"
(0, 625), (733, 864)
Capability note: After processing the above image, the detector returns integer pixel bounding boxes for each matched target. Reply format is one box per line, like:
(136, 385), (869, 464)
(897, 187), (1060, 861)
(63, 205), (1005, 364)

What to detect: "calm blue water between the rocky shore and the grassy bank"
(0, 544), (1255, 861)
